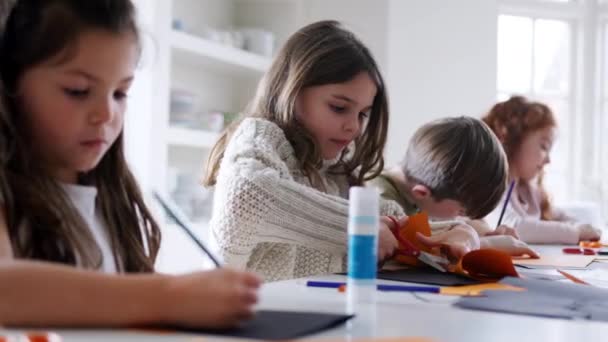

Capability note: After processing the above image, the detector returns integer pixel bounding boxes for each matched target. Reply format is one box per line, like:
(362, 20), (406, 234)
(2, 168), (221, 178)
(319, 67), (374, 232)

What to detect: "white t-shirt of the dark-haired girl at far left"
(61, 184), (117, 273)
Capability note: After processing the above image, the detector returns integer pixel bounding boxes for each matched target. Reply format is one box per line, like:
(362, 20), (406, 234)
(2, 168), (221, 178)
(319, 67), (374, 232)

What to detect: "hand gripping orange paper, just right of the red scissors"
(417, 224), (479, 262)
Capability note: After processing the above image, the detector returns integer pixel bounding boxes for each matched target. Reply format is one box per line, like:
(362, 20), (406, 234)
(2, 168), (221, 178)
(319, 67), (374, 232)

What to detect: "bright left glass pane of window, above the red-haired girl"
(497, 15), (574, 200)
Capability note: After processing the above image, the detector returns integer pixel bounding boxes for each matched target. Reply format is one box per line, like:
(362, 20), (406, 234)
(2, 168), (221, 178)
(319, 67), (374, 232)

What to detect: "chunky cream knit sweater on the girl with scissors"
(210, 118), (403, 281)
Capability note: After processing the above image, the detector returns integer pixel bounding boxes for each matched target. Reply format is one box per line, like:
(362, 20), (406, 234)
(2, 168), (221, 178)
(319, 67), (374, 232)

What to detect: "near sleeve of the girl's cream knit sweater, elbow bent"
(211, 119), (396, 267)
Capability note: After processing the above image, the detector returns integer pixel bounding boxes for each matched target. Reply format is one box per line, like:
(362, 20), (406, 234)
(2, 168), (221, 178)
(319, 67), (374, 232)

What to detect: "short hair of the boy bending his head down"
(401, 117), (507, 218)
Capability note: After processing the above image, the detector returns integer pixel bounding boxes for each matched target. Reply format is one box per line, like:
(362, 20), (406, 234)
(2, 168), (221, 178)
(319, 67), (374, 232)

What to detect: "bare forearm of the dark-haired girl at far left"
(0, 260), (169, 327)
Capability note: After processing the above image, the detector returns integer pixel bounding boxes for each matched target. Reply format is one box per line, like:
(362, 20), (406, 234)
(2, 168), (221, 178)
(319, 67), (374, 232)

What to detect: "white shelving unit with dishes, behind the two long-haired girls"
(131, 0), (302, 273)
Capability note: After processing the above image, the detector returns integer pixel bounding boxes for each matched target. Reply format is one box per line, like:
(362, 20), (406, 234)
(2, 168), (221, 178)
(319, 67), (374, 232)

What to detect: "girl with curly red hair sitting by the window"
(483, 96), (601, 244)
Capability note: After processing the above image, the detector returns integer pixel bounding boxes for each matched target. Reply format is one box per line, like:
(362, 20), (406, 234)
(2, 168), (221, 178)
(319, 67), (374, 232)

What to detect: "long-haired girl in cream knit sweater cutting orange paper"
(204, 21), (475, 281)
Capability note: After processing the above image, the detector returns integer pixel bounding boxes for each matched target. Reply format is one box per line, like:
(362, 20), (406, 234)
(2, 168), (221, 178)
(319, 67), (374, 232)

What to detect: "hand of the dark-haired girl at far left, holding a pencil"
(159, 268), (261, 328)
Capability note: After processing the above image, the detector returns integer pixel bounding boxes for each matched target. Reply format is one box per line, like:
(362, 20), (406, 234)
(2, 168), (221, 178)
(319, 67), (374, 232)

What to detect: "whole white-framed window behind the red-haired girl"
(497, 0), (608, 218)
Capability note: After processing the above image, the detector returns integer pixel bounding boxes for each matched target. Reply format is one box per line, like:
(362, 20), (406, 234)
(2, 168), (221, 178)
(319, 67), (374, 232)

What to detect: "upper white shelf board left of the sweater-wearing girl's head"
(170, 30), (271, 77)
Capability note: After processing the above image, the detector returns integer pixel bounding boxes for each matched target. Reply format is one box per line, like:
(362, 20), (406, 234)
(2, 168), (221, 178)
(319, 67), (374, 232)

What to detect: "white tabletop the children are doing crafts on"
(5, 247), (608, 342)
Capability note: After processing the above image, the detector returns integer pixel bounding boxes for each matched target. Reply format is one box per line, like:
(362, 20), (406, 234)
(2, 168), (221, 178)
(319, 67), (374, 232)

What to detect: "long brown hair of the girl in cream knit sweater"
(203, 21), (388, 186)
